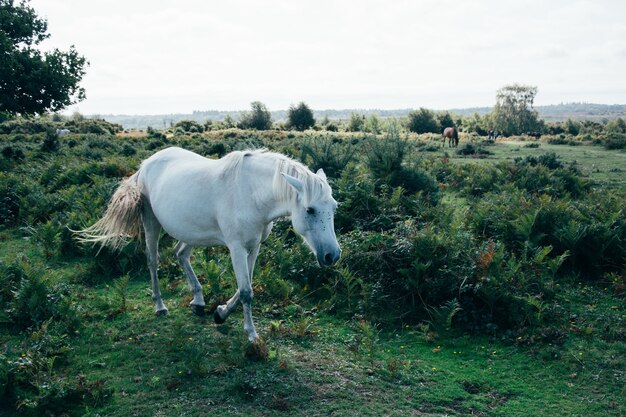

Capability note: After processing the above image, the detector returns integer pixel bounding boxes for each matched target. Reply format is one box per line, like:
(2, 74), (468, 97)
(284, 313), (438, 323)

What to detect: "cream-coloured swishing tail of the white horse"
(75, 173), (141, 250)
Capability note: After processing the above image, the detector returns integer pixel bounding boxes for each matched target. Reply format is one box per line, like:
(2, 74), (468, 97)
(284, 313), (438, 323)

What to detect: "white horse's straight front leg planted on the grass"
(225, 240), (259, 342)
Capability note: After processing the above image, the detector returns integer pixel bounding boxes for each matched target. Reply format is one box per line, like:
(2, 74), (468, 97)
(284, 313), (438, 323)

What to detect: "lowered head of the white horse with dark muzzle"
(282, 169), (341, 266)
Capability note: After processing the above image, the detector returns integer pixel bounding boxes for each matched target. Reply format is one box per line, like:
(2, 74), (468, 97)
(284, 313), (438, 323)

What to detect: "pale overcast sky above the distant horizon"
(30, 0), (626, 114)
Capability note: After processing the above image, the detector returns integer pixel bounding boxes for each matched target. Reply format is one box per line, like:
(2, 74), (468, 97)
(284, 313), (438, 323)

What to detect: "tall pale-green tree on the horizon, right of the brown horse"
(492, 84), (543, 136)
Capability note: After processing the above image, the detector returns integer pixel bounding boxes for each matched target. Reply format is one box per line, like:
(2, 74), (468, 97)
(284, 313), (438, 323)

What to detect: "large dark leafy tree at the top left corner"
(0, 0), (89, 115)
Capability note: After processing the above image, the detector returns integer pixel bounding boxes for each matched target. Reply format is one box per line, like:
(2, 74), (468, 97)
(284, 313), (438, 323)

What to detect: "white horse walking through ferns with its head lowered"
(78, 148), (341, 342)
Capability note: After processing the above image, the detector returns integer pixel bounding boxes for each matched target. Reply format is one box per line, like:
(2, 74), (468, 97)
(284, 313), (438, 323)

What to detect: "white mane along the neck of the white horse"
(222, 149), (331, 204)
